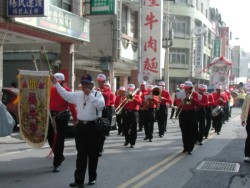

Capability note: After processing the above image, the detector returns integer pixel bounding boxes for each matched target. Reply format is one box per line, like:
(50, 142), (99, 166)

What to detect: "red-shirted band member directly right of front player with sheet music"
(196, 84), (208, 145)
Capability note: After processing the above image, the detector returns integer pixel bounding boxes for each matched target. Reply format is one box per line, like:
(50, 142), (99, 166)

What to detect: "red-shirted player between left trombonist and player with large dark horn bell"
(143, 85), (159, 142)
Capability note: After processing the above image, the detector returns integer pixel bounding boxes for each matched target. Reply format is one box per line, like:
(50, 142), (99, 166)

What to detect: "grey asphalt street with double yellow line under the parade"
(0, 108), (250, 188)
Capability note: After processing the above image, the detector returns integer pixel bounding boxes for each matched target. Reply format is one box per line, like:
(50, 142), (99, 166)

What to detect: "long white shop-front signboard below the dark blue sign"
(15, 5), (90, 42)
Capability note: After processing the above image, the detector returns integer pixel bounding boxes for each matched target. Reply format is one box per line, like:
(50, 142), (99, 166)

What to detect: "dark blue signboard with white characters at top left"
(7, 0), (49, 17)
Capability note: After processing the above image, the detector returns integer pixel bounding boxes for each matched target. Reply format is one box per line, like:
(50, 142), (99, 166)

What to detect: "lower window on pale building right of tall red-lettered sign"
(169, 48), (189, 68)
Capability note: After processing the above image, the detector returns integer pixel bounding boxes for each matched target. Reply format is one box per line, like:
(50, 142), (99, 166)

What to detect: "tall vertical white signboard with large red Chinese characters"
(141, 0), (163, 83)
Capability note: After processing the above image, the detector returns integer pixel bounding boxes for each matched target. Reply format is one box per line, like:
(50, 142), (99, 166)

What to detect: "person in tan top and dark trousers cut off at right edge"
(241, 94), (250, 162)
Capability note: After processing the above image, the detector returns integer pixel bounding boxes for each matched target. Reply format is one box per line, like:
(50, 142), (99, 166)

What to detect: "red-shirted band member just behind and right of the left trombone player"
(137, 81), (148, 132)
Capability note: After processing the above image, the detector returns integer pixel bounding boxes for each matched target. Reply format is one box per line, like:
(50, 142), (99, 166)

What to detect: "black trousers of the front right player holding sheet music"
(179, 110), (198, 152)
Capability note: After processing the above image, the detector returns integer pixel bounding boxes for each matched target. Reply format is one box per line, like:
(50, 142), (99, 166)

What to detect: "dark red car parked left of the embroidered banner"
(2, 88), (19, 130)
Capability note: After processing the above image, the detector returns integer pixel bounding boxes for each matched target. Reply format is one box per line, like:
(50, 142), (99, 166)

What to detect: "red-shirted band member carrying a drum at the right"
(212, 86), (226, 135)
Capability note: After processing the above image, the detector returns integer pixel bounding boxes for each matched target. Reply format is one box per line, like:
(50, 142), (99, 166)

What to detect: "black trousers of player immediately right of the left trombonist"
(144, 108), (155, 139)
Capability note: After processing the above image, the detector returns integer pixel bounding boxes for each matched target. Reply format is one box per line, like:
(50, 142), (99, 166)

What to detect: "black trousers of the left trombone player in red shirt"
(124, 110), (138, 145)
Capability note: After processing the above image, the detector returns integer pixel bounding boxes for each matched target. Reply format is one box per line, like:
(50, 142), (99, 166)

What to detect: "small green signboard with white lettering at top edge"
(91, 0), (115, 14)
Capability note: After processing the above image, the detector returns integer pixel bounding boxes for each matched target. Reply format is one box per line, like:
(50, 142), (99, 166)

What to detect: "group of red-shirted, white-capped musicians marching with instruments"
(109, 78), (232, 154)
